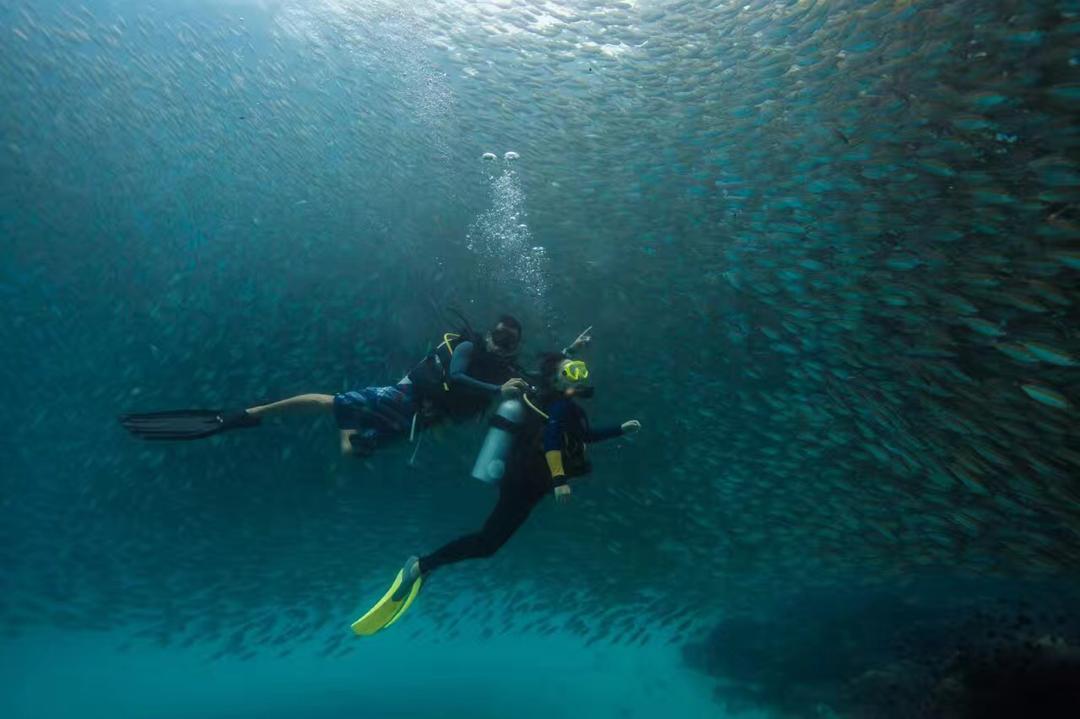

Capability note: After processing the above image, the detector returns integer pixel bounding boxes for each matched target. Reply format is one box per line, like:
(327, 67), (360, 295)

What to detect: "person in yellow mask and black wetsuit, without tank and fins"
(400, 354), (642, 578)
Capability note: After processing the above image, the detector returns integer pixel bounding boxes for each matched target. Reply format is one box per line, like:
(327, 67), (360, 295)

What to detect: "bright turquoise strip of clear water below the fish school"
(0, 632), (734, 719)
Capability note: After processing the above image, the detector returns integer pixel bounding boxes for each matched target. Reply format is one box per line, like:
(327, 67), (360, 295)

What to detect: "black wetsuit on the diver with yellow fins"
(420, 397), (622, 573)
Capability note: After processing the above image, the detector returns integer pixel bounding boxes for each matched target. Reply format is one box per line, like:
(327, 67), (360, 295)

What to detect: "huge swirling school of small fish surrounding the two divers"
(0, 0), (1080, 695)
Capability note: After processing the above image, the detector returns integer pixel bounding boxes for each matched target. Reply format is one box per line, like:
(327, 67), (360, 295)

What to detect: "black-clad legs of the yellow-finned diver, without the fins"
(406, 468), (546, 574)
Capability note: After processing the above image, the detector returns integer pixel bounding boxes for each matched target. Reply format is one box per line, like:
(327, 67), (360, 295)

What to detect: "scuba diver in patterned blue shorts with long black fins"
(120, 314), (574, 457)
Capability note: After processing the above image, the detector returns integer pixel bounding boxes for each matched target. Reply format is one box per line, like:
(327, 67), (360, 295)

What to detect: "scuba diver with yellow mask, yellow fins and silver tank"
(352, 347), (642, 636)
